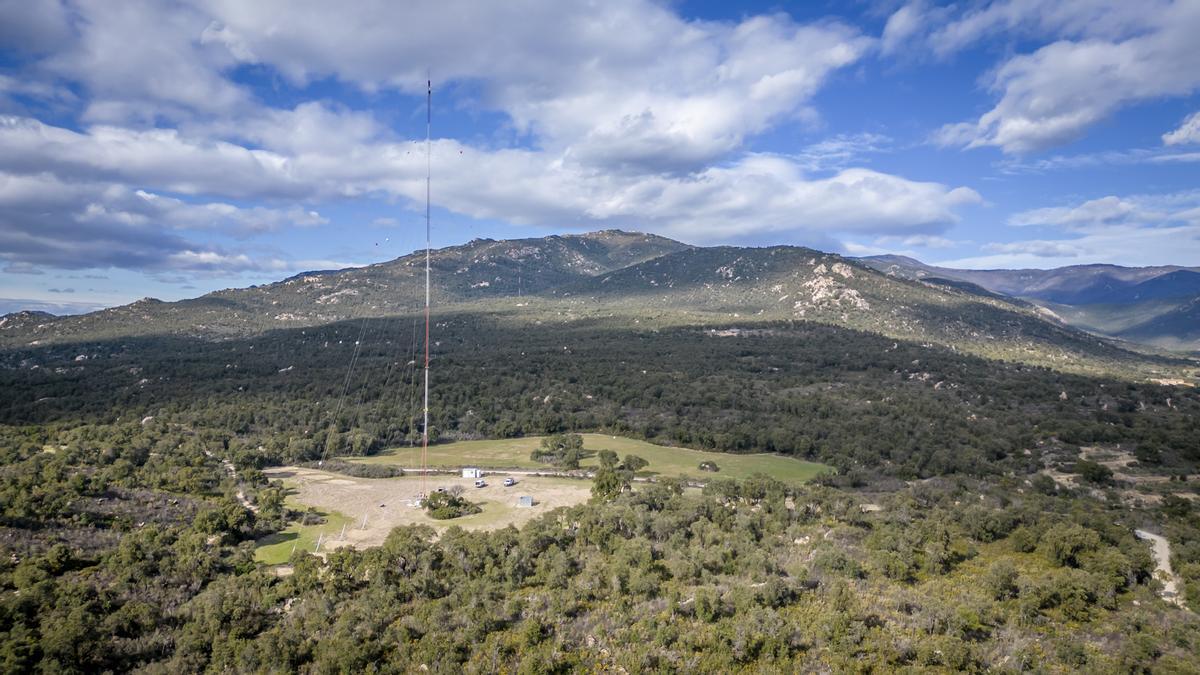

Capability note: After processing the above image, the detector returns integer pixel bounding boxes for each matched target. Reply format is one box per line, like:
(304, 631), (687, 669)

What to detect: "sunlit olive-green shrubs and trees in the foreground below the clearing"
(0, 425), (1200, 673)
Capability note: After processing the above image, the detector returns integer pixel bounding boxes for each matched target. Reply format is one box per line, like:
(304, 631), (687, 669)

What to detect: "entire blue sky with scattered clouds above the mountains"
(0, 0), (1200, 313)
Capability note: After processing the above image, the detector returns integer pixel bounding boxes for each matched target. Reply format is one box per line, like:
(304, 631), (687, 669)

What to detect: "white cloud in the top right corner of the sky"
(930, 0), (1200, 154)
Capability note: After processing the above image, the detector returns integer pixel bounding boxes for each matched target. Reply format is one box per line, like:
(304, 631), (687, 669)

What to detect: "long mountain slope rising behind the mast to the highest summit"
(0, 229), (689, 346)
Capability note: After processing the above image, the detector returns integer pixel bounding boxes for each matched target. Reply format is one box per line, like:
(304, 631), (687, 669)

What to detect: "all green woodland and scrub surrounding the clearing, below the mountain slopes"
(0, 315), (1200, 673)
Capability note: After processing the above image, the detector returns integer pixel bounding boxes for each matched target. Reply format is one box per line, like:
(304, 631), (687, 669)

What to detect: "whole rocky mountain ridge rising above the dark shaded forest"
(0, 231), (1195, 378)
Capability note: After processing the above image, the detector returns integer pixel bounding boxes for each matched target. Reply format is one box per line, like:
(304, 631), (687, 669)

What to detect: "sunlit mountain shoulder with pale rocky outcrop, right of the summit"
(554, 246), (1200, 374)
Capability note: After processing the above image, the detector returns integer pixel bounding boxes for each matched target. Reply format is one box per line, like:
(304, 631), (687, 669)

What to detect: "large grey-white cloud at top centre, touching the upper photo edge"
(196, 0), (872, 173)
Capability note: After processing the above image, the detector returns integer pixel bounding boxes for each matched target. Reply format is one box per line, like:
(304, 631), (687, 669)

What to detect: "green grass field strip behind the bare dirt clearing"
(346, 434), (829, 483)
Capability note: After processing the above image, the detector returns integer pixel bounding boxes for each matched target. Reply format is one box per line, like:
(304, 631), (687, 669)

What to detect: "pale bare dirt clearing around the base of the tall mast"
(265, 466), (592, 550)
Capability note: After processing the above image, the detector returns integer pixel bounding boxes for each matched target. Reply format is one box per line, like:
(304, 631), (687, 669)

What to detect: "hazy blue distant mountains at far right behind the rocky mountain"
(859, 256), (1200, 351)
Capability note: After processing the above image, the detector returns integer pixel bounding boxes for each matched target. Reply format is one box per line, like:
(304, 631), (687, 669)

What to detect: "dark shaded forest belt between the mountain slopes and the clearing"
(0, 315), (1200, 478)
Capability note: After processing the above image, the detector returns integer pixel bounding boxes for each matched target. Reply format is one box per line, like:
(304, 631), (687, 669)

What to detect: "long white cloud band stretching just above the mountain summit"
(0, 113), (980, 240)
